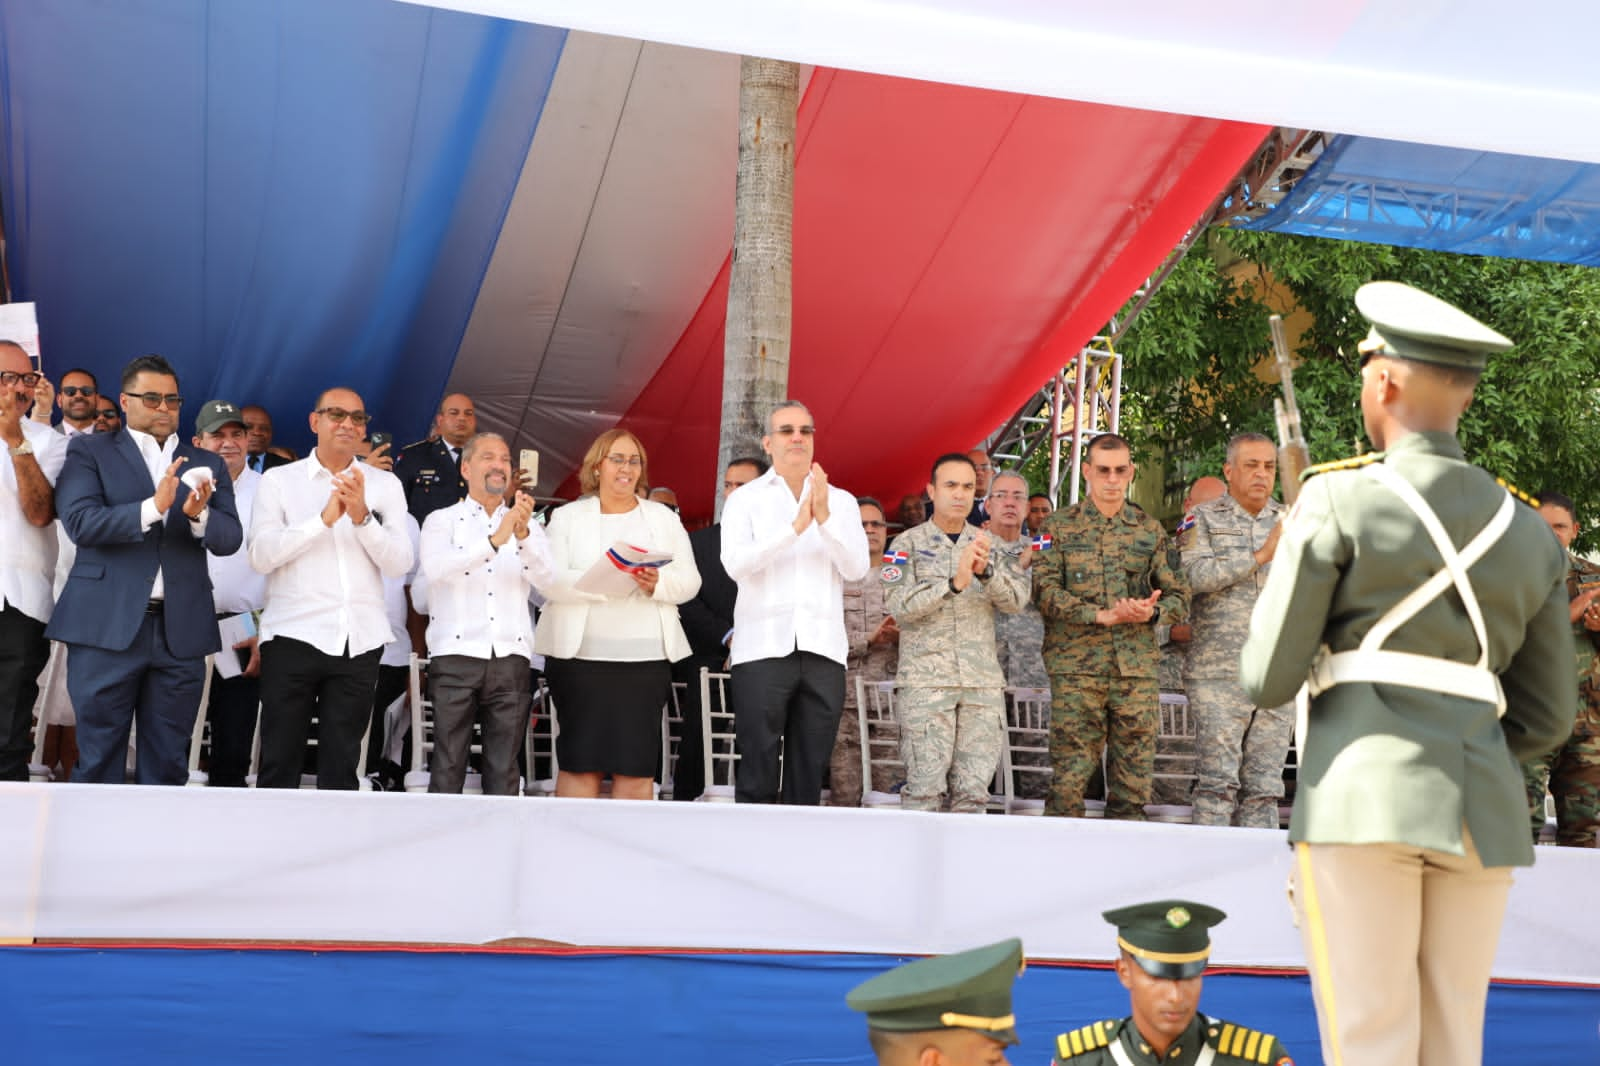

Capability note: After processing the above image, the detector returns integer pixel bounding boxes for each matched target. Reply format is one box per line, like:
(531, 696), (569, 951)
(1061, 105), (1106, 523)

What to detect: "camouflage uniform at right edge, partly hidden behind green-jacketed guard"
(1522, 552), (1600, 848)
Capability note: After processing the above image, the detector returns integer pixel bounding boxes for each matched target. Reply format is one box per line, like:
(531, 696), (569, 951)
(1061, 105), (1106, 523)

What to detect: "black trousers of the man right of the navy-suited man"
(256, 637), (384, 791)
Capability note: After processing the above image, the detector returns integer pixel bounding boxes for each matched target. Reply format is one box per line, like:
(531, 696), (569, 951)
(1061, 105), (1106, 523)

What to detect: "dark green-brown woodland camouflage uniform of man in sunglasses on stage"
(1034, 501), (1189, 820)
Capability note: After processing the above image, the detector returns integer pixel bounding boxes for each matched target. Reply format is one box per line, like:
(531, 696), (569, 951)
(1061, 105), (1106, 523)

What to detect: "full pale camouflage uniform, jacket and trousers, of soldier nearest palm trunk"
(880, 522), (1029, 813)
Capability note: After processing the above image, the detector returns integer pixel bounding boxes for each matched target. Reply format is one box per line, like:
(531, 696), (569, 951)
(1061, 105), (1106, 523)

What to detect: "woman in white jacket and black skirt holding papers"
(534, 429), (699, 799)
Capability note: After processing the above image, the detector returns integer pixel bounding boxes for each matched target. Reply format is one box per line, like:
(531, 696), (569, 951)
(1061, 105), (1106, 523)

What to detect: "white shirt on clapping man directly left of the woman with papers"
(421, 496), (555, 663)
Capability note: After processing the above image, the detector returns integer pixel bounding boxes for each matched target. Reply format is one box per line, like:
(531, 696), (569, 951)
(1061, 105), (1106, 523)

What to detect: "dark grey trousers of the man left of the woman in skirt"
(427, 655), (530, 795)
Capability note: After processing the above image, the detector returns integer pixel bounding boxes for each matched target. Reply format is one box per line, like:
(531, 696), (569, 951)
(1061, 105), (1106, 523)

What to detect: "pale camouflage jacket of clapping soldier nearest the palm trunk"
(878, 520), (1027, 690)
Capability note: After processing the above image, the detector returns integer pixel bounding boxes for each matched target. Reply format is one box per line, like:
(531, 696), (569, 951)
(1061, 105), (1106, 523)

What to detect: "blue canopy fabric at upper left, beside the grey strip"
(0, 0), (565, 445)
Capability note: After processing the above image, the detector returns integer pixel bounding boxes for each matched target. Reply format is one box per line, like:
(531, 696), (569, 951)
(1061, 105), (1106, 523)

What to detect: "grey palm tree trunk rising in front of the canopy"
(715, 56), (800, 515)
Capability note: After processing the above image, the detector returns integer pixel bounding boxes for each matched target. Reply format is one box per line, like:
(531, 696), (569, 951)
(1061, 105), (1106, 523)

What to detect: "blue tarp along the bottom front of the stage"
(0, 941), (1600, 1066)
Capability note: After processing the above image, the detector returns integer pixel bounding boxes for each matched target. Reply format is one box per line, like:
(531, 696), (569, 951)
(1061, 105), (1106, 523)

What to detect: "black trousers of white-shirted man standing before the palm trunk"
(730, 650), (845, 807)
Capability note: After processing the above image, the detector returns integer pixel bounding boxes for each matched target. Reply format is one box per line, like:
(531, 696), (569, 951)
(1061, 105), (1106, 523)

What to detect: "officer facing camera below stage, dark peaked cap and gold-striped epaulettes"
(1053, 900), (1294, 1066)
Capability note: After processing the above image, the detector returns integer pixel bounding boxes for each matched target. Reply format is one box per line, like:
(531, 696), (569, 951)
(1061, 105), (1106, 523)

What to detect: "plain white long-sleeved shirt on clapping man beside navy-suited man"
(246, 451), (413, 656)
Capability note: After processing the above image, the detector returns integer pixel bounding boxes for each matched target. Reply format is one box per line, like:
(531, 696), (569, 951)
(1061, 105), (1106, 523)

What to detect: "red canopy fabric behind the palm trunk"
(617, 70), (1269, 515)
